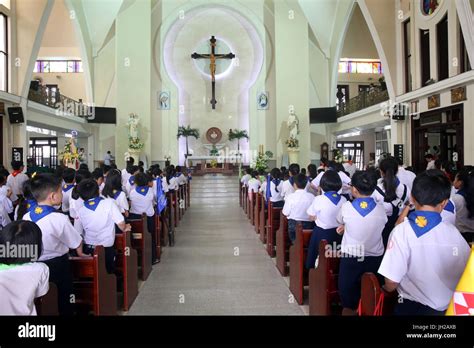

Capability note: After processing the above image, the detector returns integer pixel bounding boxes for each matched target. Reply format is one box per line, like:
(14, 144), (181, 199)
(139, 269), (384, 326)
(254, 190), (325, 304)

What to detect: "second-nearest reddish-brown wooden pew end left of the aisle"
(114, 232), (138, 311)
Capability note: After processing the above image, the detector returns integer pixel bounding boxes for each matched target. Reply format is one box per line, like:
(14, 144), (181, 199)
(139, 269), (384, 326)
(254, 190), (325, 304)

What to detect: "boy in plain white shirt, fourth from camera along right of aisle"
(282, 174), (314, 243)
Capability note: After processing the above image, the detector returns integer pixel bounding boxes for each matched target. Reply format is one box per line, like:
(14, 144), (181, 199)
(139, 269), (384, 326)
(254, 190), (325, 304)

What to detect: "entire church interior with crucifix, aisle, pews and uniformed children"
(0, 0), (474, 328)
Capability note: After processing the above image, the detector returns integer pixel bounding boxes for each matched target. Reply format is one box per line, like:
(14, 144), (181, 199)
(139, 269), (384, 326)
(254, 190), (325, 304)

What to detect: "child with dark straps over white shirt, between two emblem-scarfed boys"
(372, 157), (410, 247)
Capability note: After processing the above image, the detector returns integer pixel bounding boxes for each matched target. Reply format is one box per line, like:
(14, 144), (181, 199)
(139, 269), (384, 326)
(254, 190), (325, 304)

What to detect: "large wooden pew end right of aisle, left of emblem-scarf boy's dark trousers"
(309, 240), (340, 315)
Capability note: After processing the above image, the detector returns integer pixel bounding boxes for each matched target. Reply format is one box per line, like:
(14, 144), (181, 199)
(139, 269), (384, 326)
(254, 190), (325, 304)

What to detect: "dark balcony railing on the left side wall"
(28, 85), (91, 118)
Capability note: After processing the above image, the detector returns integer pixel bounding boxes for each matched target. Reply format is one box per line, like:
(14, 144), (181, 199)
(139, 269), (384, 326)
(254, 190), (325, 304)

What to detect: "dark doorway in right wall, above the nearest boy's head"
(412, 104), (464, 173)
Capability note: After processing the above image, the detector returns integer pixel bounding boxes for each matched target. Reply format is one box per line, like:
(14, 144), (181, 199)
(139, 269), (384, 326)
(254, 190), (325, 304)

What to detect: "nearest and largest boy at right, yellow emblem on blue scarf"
(378, 171), (470, 315)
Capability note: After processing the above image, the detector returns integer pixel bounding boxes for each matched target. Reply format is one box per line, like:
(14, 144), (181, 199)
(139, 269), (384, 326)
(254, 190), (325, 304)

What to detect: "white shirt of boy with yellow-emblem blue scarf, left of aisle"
(23, 212), (82, 261)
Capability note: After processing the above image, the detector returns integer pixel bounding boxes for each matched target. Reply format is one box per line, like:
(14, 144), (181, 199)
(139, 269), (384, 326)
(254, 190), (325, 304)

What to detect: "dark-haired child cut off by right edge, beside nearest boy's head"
(451, 169), (474, 242)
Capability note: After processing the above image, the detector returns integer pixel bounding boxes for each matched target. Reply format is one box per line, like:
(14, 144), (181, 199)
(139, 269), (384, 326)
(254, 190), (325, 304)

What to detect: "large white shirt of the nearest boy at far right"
(378, 218), (470, 311)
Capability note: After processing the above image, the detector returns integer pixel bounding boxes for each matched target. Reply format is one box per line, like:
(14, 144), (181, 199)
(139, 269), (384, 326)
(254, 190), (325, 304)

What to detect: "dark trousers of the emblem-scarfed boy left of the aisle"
(43, 254), (74, 315)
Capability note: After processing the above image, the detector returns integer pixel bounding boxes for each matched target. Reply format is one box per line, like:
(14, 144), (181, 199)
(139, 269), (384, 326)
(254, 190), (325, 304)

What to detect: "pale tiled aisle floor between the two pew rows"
(129, 176), (304, 315)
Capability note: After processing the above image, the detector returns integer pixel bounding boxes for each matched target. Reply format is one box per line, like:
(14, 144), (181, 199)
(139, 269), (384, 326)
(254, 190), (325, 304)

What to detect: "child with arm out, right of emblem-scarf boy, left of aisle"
(74, 179), (131, 273)
